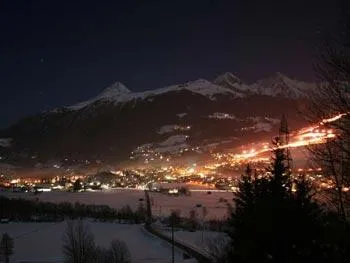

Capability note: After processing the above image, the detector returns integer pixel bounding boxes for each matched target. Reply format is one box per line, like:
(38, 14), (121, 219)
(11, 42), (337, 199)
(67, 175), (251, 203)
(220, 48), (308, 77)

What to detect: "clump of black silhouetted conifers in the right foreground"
(226, 138), (323, 263)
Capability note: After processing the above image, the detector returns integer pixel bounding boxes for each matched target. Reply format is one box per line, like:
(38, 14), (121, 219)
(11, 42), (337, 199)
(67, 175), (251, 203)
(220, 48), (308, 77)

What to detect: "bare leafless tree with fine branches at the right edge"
(305, 14), (350, 222)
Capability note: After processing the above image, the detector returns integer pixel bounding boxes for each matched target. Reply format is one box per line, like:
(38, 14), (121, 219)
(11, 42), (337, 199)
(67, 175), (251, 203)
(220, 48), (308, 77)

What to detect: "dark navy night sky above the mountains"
(0, 0), (344, 127)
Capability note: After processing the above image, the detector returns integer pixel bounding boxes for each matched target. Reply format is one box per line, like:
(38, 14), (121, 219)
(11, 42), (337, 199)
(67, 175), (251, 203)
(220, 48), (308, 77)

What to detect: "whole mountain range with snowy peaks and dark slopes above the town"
(0, 73), (317, 167)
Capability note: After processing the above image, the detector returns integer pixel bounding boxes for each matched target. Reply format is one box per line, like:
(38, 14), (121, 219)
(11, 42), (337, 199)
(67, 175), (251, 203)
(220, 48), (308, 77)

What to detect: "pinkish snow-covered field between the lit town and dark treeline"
(0, 189), (233, 219)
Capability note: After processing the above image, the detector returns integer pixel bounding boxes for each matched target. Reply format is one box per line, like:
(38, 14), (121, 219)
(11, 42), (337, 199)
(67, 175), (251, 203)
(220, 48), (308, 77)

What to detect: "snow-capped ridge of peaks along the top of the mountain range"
(68, 72), (316, 110)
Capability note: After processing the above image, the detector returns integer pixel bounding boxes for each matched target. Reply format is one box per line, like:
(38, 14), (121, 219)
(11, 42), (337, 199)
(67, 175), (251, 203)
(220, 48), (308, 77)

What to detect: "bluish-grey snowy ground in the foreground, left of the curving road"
(0, 222), (187, 263)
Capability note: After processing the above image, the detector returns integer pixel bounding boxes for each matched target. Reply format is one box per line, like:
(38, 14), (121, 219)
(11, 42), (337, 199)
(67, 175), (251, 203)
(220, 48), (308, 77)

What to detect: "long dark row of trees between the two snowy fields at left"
(0, 196), (146, 223)
